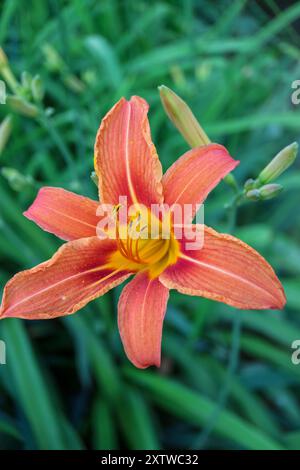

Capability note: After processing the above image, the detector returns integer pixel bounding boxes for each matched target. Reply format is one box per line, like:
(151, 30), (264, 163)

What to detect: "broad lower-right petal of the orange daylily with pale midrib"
(159, 226), (286, 309)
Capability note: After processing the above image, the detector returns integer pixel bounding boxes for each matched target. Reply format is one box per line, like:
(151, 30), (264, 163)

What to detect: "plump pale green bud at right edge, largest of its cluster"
(257, 142), (298, 185)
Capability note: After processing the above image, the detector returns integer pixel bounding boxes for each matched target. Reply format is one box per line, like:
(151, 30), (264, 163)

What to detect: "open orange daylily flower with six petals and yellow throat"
(0, 96), (285, 368)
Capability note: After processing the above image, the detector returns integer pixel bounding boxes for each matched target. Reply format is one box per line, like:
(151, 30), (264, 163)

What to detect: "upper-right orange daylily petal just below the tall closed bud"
(162, 144), (239, 223)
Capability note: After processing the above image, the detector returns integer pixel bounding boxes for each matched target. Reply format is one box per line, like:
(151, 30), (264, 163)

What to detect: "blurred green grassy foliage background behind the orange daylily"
(0, 0), (300, 449)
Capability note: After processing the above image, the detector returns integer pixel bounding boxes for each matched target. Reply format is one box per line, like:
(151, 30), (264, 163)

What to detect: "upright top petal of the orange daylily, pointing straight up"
(95, 96), (162, 206)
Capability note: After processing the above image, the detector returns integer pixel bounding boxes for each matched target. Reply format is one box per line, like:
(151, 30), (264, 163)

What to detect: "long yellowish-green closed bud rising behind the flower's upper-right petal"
(158, 85), (210, 147)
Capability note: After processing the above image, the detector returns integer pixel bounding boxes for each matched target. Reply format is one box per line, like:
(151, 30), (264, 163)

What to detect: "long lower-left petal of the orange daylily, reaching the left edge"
(0, 237), (130, 320)
